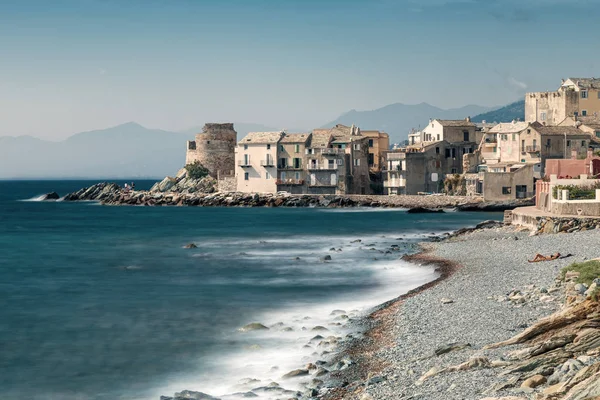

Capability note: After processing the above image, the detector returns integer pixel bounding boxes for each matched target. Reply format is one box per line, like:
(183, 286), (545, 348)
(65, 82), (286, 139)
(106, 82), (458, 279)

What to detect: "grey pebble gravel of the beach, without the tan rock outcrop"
(321, 223), (600, 400)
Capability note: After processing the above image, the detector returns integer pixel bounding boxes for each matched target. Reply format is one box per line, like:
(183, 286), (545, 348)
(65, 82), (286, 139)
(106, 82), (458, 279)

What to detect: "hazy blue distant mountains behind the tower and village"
(0, 101), (524, 179)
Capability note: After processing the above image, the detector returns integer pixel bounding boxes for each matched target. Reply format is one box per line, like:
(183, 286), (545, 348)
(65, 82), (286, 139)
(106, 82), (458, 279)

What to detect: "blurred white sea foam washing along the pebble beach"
(152, 233), (437, 399)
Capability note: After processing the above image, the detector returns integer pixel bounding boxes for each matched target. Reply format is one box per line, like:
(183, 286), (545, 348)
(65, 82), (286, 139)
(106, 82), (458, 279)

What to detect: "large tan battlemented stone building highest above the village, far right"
(525, 78), (600, 125)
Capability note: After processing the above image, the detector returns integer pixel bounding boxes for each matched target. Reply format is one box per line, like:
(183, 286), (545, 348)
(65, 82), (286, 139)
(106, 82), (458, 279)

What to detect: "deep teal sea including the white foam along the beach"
(0, 180), (502, 400)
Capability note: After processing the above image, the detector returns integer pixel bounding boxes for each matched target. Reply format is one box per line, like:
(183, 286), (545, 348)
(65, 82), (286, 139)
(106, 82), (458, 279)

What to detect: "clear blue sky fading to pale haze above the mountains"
(0, 0), (600, 140)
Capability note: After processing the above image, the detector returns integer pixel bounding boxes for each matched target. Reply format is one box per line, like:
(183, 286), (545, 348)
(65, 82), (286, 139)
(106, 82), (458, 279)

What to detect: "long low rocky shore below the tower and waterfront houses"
(58, 181), (532, 213)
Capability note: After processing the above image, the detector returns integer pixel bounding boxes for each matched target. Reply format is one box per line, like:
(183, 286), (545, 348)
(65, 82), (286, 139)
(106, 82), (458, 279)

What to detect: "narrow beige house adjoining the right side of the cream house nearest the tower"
(277, 133), (312, 194)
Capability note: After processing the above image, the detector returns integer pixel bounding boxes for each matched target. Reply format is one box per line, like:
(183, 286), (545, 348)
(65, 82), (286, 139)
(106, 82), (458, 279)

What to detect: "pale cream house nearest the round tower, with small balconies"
(235, 132), (284, 193)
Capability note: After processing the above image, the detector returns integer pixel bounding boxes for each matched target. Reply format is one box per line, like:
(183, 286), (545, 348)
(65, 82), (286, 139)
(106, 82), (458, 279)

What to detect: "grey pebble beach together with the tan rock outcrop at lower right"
(315, 223), (600, 400)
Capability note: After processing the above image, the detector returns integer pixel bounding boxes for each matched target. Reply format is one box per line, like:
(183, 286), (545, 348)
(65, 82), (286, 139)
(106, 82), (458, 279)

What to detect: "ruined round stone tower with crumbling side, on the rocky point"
(185, 123), (237, 178)
